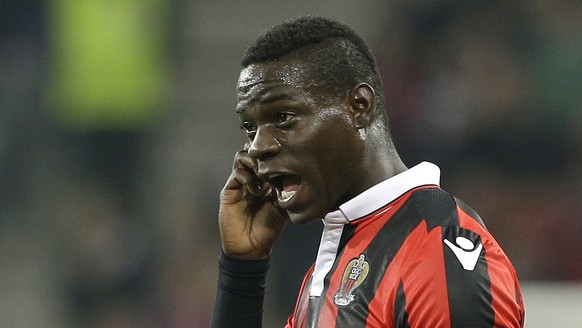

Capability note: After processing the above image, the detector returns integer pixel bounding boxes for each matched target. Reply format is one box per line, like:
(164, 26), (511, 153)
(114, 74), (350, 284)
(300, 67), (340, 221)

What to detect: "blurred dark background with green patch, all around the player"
(0, 0), (582, 328)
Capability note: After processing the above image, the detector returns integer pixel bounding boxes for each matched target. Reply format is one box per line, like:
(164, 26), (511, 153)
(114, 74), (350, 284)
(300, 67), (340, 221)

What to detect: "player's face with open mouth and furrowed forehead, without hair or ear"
(237, 62), (365, 224)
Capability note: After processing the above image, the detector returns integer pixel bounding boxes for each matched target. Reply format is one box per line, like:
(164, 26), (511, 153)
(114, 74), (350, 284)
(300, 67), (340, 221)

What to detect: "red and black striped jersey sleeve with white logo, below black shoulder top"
(395, 211), (524, 327)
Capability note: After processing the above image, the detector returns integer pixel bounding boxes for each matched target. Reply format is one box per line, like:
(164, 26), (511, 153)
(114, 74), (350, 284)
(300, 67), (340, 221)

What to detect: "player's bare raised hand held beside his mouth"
(218, 150), (288, 260)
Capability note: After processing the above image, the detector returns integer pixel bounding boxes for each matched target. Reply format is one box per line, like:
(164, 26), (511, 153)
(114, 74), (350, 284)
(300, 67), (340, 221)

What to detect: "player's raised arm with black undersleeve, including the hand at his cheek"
(212, 150), (287, 328)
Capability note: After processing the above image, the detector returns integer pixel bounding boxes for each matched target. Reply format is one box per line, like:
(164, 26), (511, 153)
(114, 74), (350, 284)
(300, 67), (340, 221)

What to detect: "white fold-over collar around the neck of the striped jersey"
(323, 162), (440, 223)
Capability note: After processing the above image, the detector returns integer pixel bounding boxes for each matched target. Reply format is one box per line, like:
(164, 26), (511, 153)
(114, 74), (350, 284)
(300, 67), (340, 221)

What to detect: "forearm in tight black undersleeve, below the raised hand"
(211, 254), (270, 328)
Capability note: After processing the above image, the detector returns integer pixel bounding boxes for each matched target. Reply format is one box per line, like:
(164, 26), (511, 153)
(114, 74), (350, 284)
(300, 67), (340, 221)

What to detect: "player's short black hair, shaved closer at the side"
(241, 16), (387, 122)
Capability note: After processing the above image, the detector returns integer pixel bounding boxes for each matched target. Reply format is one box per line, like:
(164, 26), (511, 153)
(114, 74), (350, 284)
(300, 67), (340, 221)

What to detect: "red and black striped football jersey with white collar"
(287, 162), (525, 328)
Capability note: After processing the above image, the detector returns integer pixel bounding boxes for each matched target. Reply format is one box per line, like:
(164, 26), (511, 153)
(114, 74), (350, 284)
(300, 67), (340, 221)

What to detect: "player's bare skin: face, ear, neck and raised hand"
(219, 60), (406, 260)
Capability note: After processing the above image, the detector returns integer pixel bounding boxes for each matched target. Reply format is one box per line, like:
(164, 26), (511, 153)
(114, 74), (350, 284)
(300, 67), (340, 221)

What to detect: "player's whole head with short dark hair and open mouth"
(237, 17), (402, 224)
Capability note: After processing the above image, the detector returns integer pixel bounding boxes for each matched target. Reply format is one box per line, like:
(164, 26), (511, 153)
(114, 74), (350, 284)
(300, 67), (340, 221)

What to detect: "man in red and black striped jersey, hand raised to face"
(213, 17), (524, 328)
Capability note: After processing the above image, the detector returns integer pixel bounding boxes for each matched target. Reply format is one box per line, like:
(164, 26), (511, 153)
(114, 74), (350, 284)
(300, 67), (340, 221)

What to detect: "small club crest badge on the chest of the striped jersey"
(333, 254), (370, 306)
